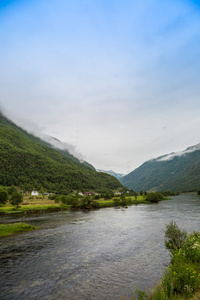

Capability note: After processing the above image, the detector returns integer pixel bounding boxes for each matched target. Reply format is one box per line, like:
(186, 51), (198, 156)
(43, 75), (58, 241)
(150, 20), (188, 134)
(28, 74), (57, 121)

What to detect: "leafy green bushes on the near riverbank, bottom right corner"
(149, 222), (200, 300)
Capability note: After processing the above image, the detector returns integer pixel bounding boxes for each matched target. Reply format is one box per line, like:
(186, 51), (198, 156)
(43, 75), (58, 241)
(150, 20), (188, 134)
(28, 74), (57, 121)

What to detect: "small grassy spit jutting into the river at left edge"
(0, 223), (38, 237)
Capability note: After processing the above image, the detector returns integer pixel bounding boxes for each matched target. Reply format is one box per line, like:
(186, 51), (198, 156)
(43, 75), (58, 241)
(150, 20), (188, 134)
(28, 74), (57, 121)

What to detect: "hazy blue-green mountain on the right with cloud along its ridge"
(120, 144), (200, 192)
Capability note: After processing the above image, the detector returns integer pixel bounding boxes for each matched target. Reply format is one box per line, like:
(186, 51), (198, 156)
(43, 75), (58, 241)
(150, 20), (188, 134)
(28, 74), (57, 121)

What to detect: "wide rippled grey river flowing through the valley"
(0, 195), (200, 300)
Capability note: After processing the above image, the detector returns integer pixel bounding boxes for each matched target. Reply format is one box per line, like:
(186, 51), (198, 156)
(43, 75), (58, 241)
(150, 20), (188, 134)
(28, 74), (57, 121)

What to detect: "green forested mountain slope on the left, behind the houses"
(0, 113), (123, 193)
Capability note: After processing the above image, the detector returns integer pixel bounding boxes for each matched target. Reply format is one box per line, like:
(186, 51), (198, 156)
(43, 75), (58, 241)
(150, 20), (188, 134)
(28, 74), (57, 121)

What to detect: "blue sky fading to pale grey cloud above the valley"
(0, 0), (200, 174)
